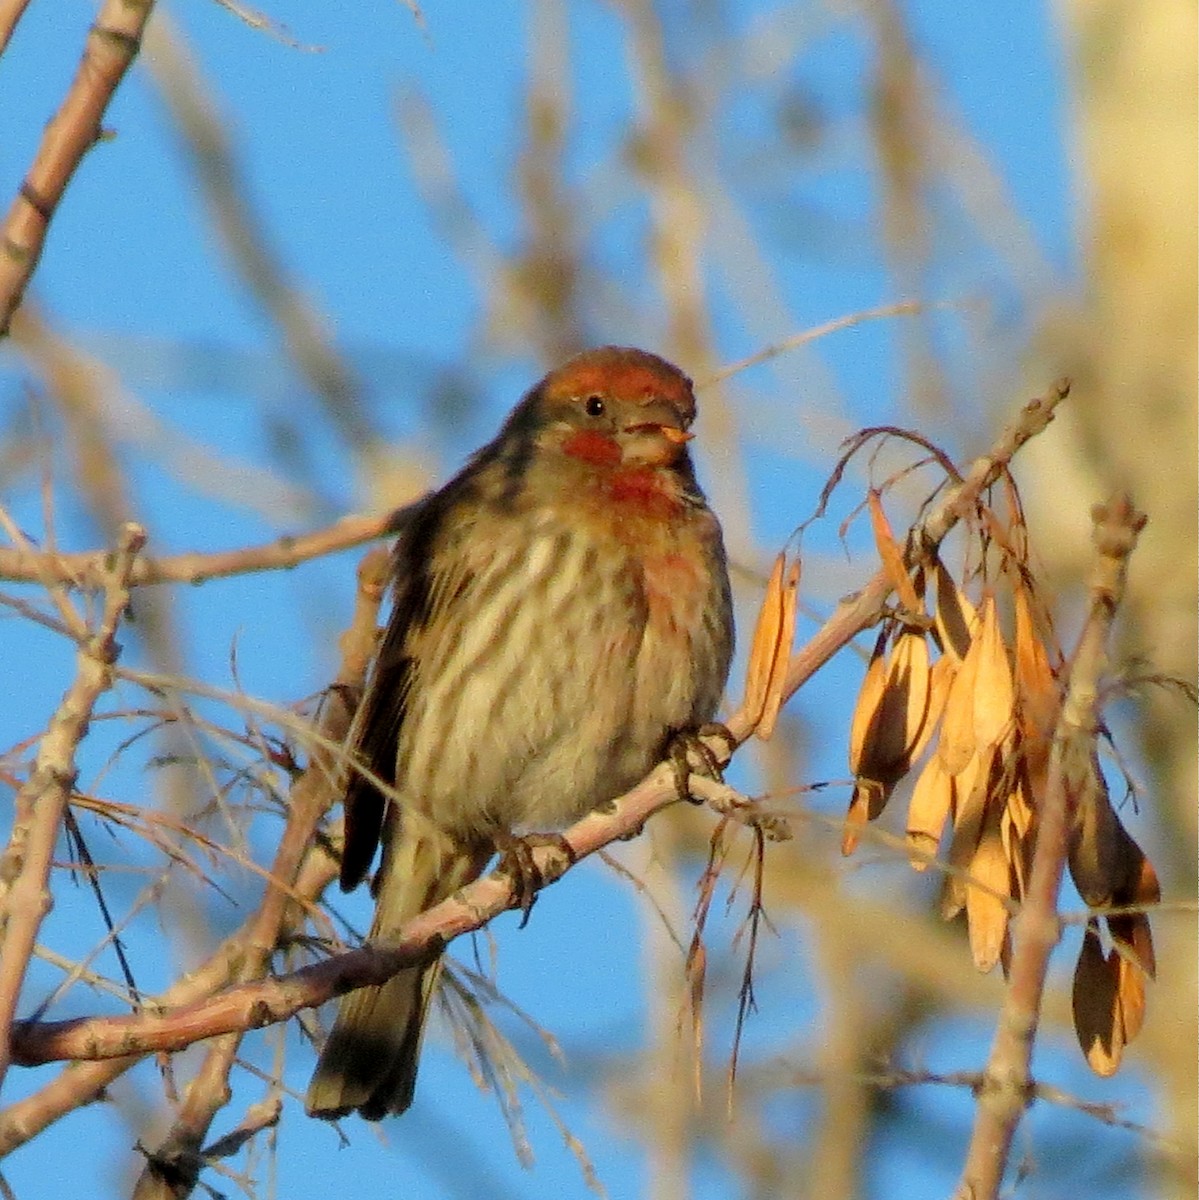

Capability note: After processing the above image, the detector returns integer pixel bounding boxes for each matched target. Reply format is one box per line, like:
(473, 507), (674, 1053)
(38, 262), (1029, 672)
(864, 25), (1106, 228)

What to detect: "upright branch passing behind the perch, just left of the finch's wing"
(133, 546), (390, 1200)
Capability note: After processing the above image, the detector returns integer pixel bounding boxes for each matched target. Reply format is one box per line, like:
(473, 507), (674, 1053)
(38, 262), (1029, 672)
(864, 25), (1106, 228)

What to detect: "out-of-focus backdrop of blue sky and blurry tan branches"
(0, 0), (1199, 1200)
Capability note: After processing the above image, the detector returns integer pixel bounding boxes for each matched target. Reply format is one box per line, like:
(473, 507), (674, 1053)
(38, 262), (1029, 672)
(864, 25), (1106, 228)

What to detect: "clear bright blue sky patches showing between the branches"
(0, 0), (1152, 1200)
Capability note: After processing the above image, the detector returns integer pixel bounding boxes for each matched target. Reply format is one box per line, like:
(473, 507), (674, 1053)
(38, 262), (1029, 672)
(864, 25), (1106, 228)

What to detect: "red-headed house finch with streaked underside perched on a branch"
(307, 346), (733, 1121)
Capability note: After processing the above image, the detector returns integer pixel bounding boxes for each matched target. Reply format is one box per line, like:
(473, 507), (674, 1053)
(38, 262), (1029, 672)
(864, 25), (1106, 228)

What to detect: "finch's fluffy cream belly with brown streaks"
(397, 532), (724, 839)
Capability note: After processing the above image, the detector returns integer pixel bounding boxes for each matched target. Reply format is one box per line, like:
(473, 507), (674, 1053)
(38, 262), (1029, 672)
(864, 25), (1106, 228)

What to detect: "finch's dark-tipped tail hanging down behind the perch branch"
(305, 817), (491, 1121)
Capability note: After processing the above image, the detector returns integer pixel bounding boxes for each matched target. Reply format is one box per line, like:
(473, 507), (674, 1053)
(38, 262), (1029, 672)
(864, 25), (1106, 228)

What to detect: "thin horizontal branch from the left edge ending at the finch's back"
(0, 509), (407, 588)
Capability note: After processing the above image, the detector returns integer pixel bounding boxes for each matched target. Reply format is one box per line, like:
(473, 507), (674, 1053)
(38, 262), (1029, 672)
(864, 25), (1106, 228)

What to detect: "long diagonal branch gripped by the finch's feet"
(7, 385), (1066, 1070)
